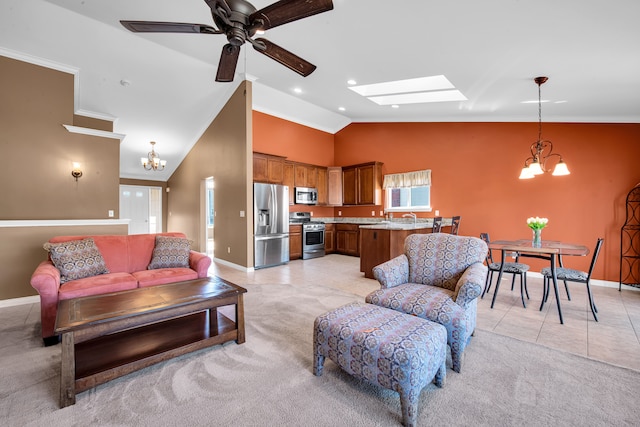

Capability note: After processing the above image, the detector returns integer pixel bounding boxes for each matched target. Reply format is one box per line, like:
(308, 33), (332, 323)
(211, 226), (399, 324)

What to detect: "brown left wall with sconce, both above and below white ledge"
(0, 56), (127, 299)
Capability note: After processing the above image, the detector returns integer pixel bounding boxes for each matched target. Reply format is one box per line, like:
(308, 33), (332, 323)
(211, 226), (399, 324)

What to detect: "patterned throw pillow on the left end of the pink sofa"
(44, 238), (109, 284)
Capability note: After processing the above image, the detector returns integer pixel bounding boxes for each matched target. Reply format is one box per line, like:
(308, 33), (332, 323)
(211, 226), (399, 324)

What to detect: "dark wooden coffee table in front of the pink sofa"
(55, 277), (247, 408)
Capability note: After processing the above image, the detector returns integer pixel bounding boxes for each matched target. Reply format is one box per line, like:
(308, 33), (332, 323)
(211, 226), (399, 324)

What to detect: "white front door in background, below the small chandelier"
(120, 185), (162, 234)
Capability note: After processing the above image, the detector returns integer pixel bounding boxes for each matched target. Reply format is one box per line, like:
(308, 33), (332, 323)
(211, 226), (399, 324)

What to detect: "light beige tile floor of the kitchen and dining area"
(211, 255), (640, 370)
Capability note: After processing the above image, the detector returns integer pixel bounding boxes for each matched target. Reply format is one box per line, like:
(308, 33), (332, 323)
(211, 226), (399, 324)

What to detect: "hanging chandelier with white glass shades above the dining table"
(520, 77), (570, 179)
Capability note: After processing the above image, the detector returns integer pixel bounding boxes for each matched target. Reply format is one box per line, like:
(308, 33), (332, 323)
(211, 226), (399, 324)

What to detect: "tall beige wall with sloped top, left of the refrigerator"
(167, 81), (253, 267)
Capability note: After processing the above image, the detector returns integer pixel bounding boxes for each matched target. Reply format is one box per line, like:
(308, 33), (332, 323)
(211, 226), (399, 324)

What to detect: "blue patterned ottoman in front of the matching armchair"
(313, 302), (447, 426)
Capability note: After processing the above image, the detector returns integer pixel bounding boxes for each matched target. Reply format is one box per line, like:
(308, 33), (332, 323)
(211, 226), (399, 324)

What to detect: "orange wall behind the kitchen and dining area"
(254, 112), (640, 282)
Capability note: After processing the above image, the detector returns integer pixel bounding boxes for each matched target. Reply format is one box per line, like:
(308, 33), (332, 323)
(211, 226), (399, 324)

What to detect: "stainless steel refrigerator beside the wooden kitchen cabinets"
(253, 183), (289, 268)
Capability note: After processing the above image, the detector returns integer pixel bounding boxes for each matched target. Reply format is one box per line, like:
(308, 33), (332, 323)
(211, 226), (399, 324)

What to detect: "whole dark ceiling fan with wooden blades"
(120, 0), (333, 82)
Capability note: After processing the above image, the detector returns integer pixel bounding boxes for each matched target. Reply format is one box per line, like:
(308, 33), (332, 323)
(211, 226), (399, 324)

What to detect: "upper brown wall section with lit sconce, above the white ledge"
(0, 56), (120, 220)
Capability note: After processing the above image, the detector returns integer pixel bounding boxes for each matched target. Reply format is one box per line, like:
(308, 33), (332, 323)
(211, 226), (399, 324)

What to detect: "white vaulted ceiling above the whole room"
(0, 0), (640, 180)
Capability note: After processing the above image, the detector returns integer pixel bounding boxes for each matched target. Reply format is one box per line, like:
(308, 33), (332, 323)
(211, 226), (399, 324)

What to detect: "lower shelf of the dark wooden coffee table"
(75, 310), (238, 393)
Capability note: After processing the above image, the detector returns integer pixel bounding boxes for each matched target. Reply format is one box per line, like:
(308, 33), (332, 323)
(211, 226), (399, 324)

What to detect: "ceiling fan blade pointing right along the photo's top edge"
(249, 0), (333, 30)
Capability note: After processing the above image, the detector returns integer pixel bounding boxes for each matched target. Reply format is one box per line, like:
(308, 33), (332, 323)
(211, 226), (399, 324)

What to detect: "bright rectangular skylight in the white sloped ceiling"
(349, 75), (467, 105)
